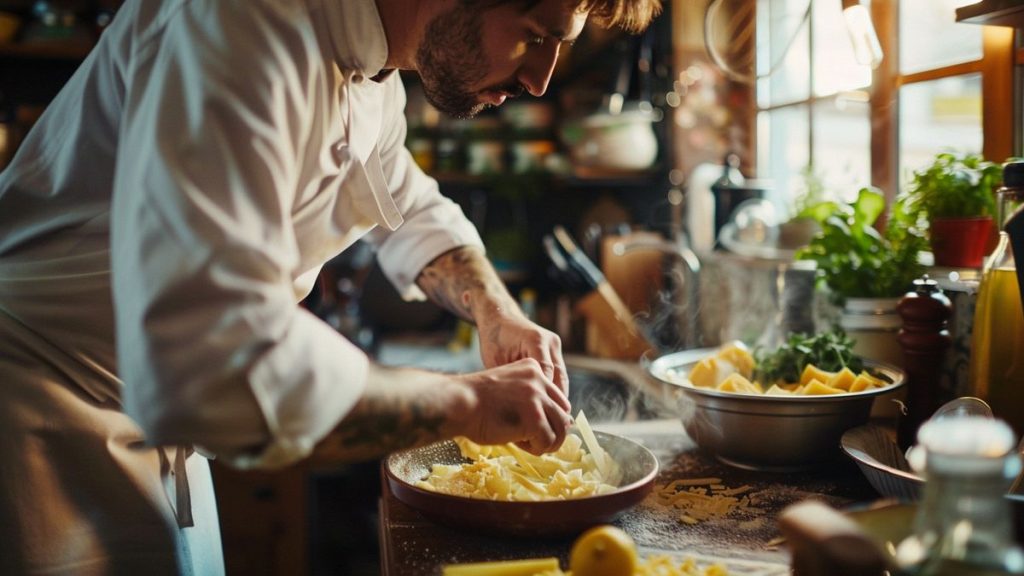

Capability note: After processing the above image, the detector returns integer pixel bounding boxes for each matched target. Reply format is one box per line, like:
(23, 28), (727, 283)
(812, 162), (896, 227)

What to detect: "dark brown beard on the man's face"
(416, 4), (523, 118)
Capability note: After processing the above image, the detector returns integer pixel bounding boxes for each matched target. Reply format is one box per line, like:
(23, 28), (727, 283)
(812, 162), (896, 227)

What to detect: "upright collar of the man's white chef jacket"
(310, 0), (387, 83)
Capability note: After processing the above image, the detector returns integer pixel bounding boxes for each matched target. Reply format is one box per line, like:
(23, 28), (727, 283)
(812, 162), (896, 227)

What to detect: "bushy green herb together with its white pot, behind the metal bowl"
(797, 188), (927, 365)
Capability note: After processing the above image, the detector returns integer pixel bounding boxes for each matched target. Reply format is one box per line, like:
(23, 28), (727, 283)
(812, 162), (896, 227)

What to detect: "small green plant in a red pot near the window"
(893, 152), (1002, 268)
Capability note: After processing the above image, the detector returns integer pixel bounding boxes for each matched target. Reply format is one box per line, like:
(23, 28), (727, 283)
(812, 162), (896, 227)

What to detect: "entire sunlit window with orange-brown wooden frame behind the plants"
(756, 0), (1015, 207)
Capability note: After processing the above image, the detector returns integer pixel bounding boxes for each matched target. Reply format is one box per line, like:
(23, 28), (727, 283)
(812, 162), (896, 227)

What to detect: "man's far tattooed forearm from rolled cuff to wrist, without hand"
(416, 246), (518, 324)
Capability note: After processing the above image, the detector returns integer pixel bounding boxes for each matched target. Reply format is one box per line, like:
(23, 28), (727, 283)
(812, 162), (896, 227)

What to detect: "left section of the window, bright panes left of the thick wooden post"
(757, 0), (871, 213)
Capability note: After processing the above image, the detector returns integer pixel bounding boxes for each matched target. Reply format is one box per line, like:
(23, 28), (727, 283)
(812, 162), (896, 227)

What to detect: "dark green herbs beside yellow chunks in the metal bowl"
(754, 328), (864, 384)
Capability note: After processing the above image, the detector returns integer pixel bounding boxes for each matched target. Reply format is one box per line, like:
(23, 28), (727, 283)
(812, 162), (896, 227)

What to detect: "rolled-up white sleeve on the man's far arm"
(374, 74), (483, 299)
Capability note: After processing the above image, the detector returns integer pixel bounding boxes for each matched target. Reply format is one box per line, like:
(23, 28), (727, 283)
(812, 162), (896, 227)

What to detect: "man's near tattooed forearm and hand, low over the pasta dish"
(313, 359), (569, 462)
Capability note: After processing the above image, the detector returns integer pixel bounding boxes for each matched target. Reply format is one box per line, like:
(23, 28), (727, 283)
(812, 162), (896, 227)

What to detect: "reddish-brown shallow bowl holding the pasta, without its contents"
(384, 430), (658, 537)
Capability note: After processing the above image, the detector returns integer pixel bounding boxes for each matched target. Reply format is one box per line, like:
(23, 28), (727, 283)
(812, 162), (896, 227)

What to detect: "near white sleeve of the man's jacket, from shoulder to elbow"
(112, 1), (368, 466)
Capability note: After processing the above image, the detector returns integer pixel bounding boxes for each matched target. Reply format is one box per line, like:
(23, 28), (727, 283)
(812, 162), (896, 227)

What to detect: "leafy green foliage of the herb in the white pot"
(797, 188), (926, 304)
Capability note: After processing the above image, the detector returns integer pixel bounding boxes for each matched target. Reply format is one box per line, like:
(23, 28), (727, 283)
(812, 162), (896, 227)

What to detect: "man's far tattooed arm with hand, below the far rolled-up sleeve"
(417, 246), (568, 393)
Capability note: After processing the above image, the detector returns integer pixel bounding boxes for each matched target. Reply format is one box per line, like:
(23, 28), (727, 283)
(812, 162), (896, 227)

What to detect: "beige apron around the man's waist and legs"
(0, 253), (224, 576)
